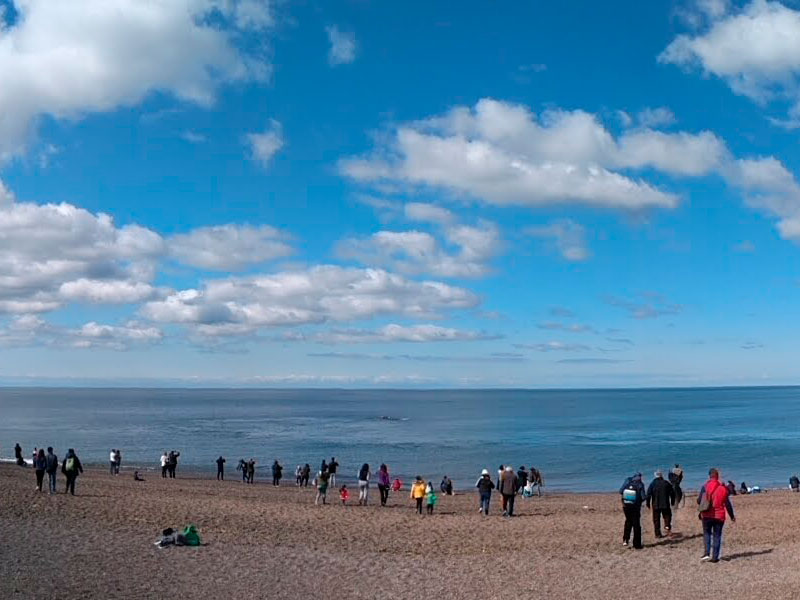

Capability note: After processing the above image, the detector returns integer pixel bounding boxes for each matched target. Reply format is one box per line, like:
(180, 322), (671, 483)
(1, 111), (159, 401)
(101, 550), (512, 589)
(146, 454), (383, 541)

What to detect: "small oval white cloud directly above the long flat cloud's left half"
(167, 224), (293, 271)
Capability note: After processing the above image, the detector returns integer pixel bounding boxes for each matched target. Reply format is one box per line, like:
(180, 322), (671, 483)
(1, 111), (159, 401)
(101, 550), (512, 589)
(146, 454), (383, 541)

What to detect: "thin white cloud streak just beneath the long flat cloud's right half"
(316, 324), (498, 344)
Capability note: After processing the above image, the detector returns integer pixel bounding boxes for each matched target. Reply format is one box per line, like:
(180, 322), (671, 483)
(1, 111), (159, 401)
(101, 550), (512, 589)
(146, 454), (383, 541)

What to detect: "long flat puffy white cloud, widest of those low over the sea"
(141, 265), (479, 336)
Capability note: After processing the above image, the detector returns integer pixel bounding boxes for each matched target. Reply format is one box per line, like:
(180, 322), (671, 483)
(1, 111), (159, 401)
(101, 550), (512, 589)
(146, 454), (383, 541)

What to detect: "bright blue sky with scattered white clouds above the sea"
(0, 0), (800, 388)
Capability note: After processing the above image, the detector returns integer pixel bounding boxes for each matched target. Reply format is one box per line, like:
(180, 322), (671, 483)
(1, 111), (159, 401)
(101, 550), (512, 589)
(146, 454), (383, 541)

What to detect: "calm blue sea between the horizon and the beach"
(0, 388), (800, 491)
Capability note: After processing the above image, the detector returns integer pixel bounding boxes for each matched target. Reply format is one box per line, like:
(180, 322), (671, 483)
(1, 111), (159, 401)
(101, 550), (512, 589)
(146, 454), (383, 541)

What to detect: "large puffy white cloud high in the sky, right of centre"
(340, 99), (726, 209)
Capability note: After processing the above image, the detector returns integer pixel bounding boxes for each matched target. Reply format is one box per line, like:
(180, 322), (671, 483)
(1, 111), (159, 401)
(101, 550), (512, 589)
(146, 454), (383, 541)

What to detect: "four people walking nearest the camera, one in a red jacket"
(619, 464), (736, 563)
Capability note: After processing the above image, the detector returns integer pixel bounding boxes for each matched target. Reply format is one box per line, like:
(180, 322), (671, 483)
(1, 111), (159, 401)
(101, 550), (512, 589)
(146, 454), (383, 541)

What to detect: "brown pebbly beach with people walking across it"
(0, 465), (800, 599)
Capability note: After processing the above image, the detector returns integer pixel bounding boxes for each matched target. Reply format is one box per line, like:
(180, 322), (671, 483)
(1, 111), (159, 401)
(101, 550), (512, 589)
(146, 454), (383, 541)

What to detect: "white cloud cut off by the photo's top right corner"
(659, 0), (800, 112)
